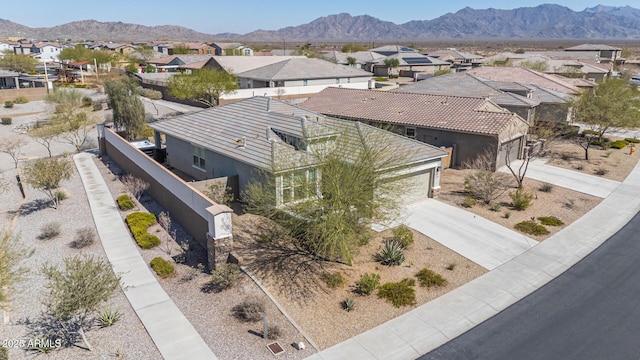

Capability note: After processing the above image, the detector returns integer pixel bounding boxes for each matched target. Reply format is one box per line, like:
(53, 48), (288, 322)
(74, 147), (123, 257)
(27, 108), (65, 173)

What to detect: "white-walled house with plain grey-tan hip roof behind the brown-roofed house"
(236, 58), (372, 89)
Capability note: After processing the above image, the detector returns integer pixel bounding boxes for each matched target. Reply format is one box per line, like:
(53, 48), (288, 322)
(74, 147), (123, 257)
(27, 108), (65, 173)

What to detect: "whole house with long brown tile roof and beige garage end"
(300, 88), (529, 167)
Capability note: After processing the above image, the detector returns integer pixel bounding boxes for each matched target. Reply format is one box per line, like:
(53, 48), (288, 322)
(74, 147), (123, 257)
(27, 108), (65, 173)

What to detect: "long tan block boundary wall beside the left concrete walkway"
(104, 129), (215, 248)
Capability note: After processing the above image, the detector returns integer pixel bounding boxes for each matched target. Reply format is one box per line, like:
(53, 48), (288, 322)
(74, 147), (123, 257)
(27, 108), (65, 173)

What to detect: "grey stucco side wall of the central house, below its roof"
(166, 135), (259, 194)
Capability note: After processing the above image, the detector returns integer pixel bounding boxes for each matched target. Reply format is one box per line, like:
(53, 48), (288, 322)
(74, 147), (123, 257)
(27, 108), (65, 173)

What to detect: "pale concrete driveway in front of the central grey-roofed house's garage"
(404, 199), (538, 270)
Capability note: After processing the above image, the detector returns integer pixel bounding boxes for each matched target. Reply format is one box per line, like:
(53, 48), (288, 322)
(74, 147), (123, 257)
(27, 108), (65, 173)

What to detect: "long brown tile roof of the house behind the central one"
(300, 88), (526, 135)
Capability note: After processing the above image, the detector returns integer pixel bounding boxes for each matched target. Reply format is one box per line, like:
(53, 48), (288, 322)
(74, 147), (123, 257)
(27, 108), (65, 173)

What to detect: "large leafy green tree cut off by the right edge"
(572, 77), (640, 160)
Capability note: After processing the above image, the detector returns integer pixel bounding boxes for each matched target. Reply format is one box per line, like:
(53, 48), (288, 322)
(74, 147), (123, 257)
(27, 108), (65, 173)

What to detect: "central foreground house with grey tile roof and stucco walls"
(150, 96), (446, 206)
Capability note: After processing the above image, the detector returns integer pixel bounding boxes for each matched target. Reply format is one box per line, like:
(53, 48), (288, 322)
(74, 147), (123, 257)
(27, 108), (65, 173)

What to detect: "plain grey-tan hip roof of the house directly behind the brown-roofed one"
(237, 58), (373, 81)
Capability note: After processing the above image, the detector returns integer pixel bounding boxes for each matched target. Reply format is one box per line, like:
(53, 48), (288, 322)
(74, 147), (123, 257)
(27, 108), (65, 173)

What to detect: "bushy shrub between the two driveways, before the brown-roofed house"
(463, 151), (513, 204)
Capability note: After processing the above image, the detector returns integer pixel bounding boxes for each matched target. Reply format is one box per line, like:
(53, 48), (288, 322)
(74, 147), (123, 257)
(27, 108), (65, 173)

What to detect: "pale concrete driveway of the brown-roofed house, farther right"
(499, 159), (620, 198)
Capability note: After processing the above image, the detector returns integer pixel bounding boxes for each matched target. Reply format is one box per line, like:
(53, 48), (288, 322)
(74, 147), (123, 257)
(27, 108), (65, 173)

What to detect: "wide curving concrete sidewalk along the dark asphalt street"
(309, 159), (640, 360)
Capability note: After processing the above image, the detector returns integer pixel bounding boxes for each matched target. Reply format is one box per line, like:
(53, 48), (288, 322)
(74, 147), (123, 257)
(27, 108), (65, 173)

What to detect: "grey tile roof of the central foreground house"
(149, 96), (446, 171)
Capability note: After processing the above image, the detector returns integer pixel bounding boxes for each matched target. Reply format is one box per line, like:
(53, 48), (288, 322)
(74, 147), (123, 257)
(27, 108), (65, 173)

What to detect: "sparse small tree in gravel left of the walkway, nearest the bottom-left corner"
(42, 256), (120, 350)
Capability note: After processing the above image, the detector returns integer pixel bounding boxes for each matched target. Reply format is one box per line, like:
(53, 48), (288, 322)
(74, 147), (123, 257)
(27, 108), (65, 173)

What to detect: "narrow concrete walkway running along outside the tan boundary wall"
(73, 153), (217, 360)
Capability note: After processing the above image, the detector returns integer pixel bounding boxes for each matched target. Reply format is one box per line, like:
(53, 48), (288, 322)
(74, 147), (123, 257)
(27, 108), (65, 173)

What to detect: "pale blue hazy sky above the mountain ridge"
(0, 0), (640, 34)
